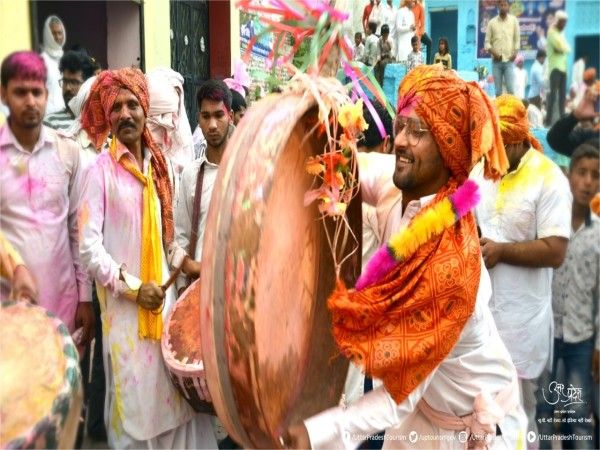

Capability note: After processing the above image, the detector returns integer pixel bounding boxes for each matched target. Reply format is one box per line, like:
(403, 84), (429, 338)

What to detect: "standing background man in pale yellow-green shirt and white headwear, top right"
(546, 10), (571, 127)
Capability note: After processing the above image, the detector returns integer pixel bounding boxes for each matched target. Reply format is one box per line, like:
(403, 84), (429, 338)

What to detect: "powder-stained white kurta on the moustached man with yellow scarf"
(79, 146), (216, 448)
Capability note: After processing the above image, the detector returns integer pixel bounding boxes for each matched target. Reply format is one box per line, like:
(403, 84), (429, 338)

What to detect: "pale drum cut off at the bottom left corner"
(0, 302), (83, 448)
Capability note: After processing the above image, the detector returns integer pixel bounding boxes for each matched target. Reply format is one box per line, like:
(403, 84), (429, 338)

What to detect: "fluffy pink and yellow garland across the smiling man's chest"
(356, 180), (480, 291)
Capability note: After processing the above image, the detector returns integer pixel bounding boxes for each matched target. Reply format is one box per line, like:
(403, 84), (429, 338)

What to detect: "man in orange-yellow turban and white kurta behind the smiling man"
(473, 95), (571, 448)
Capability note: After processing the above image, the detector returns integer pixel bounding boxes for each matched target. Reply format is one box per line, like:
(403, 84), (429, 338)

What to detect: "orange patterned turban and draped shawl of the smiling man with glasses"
(328, 66), (508, 403)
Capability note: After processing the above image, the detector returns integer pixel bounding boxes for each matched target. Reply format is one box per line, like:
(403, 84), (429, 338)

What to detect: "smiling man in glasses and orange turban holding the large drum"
(283, 66), (524, 449)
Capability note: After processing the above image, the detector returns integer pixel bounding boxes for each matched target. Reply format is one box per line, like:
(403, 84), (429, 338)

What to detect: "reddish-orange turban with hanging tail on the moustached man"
(81, 68), (174, 248)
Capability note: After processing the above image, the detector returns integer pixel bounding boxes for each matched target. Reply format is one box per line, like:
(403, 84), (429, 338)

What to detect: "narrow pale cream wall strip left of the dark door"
(143, 0), (171, 71)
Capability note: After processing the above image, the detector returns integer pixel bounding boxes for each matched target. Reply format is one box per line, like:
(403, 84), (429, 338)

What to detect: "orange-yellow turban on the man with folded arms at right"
(495, 94), (544, 152)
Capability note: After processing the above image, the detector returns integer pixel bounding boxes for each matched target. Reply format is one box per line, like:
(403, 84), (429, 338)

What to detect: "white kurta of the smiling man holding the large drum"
(305, 153), (526, 449)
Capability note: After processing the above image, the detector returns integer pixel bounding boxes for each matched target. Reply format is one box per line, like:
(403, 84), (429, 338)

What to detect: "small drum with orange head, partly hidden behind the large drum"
(161, 280), (215, 414)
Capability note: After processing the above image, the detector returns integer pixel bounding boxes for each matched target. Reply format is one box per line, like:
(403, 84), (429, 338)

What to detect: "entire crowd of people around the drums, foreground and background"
(0, 5), (600, 449)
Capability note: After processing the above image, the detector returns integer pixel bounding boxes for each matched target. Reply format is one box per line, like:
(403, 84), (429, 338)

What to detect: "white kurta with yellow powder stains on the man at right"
(472, 148), (572, 379)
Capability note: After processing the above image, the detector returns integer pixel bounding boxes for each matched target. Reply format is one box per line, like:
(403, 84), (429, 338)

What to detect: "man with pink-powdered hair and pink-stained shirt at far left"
(0, 51), (94, 345)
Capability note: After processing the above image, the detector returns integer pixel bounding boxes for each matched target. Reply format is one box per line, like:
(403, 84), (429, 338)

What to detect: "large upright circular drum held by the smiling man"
(201, 93), (362, 448)
